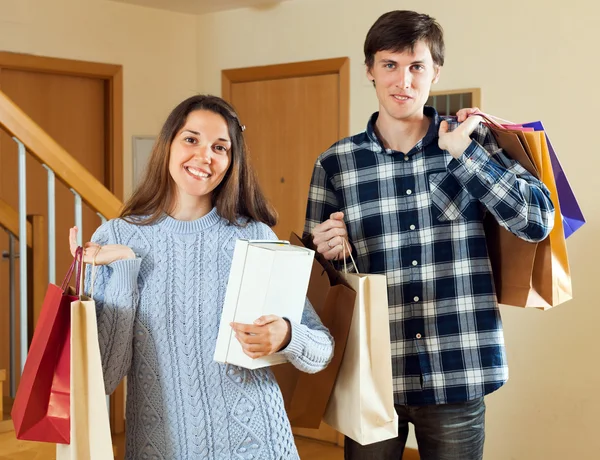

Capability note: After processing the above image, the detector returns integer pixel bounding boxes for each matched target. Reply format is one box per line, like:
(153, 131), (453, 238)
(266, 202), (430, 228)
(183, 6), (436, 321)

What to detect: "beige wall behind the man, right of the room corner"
(198, 0), (600, 460)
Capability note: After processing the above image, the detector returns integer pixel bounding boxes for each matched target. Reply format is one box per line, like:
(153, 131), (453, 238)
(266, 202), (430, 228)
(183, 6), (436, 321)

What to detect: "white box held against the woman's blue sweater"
(214, 240), (314, 369)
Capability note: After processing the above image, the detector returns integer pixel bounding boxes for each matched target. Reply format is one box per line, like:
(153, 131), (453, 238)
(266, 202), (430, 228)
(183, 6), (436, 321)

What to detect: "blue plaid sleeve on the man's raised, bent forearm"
(448, 125), (554, 242)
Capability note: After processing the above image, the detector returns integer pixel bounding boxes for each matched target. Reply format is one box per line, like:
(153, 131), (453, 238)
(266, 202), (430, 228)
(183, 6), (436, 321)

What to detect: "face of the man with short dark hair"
(367, 41), (440, 121)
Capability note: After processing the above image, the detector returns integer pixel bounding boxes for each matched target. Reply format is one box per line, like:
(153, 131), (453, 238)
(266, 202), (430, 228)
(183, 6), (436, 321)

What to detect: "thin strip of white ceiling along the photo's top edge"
(111, 0), (289, 14)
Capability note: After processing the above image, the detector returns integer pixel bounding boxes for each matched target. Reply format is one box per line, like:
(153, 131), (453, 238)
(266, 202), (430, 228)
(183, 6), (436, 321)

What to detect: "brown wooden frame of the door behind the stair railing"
(0, 51), (123, 201)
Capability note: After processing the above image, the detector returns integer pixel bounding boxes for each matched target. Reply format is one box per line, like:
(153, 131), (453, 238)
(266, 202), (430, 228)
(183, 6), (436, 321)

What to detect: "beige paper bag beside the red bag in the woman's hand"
(56, 260), (114, 460)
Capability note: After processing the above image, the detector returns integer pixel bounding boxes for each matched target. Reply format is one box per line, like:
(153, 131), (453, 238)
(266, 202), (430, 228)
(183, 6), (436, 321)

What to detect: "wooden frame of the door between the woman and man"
(221, 57), (350, 139)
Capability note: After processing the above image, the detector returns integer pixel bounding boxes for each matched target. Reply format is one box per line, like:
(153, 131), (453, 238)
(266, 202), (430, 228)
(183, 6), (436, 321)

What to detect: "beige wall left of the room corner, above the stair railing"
(0, 0), (198, 195)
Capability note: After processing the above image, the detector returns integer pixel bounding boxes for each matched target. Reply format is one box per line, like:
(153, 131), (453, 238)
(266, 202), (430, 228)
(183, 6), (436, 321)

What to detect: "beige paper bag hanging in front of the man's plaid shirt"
(323, 244), (398, 445)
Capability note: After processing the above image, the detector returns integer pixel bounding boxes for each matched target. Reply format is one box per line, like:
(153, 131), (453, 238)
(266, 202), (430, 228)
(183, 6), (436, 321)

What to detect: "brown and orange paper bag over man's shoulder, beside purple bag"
(485, 122), (572, 309)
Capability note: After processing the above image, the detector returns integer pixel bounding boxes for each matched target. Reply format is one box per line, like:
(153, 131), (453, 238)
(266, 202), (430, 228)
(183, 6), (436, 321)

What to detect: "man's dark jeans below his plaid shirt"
(344, 398), (485, 460)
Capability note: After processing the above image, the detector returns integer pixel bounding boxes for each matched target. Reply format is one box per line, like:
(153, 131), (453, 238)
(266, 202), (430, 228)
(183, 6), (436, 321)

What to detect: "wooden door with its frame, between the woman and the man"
(223, 58), (349, 443)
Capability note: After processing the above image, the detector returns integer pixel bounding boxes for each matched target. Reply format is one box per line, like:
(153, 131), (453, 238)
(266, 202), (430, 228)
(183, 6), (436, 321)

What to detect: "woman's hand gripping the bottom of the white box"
(229, 315), (292, 359)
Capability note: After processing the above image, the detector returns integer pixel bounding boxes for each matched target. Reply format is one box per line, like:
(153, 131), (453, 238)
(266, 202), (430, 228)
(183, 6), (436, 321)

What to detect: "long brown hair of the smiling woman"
(120, 95), (277, 227)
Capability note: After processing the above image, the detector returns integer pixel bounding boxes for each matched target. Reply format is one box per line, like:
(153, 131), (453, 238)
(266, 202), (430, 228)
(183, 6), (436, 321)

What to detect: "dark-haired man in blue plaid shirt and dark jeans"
(305, 11), (554, 460)
